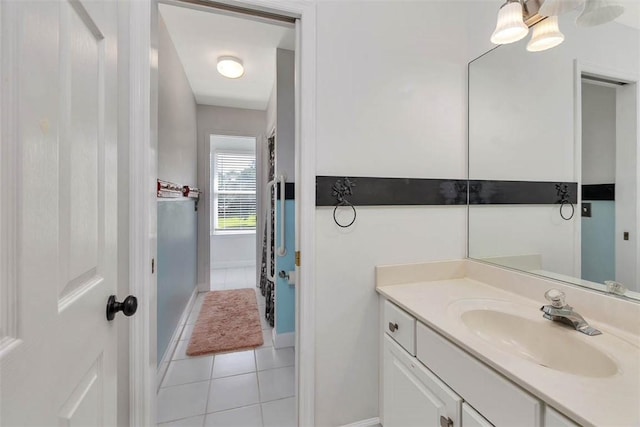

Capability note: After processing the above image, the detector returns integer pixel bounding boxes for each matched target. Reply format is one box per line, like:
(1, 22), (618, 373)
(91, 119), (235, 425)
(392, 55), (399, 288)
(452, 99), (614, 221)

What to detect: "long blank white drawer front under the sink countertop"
(416, 323), (542, 427)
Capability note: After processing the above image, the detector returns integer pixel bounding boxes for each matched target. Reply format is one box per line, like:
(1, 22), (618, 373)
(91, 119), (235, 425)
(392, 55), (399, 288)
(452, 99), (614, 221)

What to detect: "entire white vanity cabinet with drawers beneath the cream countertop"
(381, 300), (544, 427)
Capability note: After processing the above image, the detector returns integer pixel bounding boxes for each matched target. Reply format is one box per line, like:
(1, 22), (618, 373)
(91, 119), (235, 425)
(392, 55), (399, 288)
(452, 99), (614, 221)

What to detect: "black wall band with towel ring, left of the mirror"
(316, 176), (467, 206)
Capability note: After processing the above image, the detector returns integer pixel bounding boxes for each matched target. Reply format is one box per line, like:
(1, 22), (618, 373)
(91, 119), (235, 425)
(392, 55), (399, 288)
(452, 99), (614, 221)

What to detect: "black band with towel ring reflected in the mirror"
(469, 180), (578, 205)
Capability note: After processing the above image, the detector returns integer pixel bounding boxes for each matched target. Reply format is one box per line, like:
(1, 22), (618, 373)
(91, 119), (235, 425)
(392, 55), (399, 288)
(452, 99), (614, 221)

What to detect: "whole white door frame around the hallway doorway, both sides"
(128, 0), (316, 425)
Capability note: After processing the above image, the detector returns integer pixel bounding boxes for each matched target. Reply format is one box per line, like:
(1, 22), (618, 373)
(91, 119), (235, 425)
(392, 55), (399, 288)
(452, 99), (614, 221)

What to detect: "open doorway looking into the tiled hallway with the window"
(157, 2), (296, 426)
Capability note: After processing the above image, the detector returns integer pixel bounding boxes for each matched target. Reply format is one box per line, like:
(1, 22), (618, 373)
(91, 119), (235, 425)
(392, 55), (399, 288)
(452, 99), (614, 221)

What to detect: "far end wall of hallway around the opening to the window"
(197, 105), (266, 291)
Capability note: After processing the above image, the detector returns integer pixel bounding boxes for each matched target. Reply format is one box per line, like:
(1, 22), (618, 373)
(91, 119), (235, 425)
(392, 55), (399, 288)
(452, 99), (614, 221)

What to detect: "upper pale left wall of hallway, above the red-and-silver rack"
(158, 17), (197, 185)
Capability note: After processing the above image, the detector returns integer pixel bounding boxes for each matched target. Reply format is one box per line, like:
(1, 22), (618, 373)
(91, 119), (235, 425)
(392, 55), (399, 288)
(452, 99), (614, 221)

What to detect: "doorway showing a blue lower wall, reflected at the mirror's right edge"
(580, 72), (640, 292)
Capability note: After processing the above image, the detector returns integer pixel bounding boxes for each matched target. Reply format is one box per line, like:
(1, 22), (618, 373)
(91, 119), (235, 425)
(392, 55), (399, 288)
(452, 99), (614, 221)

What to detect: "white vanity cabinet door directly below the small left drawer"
(382, 336), (462, 427)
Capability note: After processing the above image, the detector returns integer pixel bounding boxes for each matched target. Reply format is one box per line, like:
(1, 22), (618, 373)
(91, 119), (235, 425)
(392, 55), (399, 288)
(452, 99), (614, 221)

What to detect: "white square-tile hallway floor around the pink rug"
(158, 268), (295, 427)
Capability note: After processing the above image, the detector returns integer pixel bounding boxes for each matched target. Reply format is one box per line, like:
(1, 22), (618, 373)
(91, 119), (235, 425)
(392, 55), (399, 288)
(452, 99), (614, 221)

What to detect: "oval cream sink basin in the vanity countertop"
(450, 301), (618, 377)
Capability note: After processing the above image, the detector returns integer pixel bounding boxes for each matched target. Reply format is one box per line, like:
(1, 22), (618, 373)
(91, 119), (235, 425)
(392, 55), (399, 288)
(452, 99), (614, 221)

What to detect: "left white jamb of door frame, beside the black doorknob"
(127, 0), (158, 426)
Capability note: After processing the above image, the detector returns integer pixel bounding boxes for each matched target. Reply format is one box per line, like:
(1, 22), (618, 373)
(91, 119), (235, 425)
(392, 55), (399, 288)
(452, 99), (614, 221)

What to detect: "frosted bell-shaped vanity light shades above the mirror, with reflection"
(491, 0), (624, 52)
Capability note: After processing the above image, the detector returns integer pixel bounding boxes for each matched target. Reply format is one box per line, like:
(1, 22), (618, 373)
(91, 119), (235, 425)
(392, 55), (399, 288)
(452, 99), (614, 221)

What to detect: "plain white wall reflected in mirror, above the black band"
(469, 43), (575, 181)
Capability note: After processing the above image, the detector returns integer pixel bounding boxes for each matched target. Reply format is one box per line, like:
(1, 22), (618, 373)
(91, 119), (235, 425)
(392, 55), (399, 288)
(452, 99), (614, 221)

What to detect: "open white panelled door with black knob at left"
(0, 0), (123, 426)
